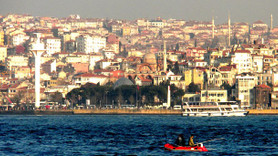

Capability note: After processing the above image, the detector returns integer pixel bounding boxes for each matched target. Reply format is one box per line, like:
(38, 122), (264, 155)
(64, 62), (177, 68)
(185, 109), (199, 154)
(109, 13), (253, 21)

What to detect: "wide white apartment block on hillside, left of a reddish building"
(76, 35), (106, 53)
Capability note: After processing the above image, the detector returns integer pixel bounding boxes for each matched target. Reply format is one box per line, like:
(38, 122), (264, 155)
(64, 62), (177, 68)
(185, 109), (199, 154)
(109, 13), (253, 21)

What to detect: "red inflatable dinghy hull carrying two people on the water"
(164, 144), (208, 152)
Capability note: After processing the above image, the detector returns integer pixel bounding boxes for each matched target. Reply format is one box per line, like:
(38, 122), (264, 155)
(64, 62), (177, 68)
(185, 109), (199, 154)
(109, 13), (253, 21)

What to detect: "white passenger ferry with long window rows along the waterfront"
(182, 101), (248, 116)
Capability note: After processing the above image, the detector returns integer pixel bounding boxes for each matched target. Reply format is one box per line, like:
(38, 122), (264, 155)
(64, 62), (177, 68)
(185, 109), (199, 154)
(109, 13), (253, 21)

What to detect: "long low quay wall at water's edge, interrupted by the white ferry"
(0, 109), (278, 115)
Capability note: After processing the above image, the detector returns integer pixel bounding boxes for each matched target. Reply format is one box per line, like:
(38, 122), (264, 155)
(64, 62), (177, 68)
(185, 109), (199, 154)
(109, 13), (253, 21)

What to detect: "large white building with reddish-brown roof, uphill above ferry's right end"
(232, 50), (252, 74)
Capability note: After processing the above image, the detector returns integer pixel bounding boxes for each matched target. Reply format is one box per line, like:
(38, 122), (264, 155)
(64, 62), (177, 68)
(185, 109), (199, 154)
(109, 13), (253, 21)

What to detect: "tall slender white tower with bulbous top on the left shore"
(30, 33), (45, 108)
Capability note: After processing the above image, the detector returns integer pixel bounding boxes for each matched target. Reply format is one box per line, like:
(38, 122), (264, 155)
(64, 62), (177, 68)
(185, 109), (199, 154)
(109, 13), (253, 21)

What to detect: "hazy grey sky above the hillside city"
(0, 0), (278, 25)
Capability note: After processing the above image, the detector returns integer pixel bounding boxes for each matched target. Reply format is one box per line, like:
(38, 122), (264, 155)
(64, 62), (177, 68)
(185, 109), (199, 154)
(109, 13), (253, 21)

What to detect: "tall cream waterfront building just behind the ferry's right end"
(235, 74), (257, 107)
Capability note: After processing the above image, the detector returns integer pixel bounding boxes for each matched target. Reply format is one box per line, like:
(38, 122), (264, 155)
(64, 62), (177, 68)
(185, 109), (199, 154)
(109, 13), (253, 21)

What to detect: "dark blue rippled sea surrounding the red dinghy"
(0, 115), (278, 155)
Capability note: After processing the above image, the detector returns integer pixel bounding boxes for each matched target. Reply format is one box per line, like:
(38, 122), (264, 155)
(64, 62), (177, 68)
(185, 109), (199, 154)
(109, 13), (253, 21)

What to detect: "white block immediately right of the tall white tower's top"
(43, 37), (61, 56)
